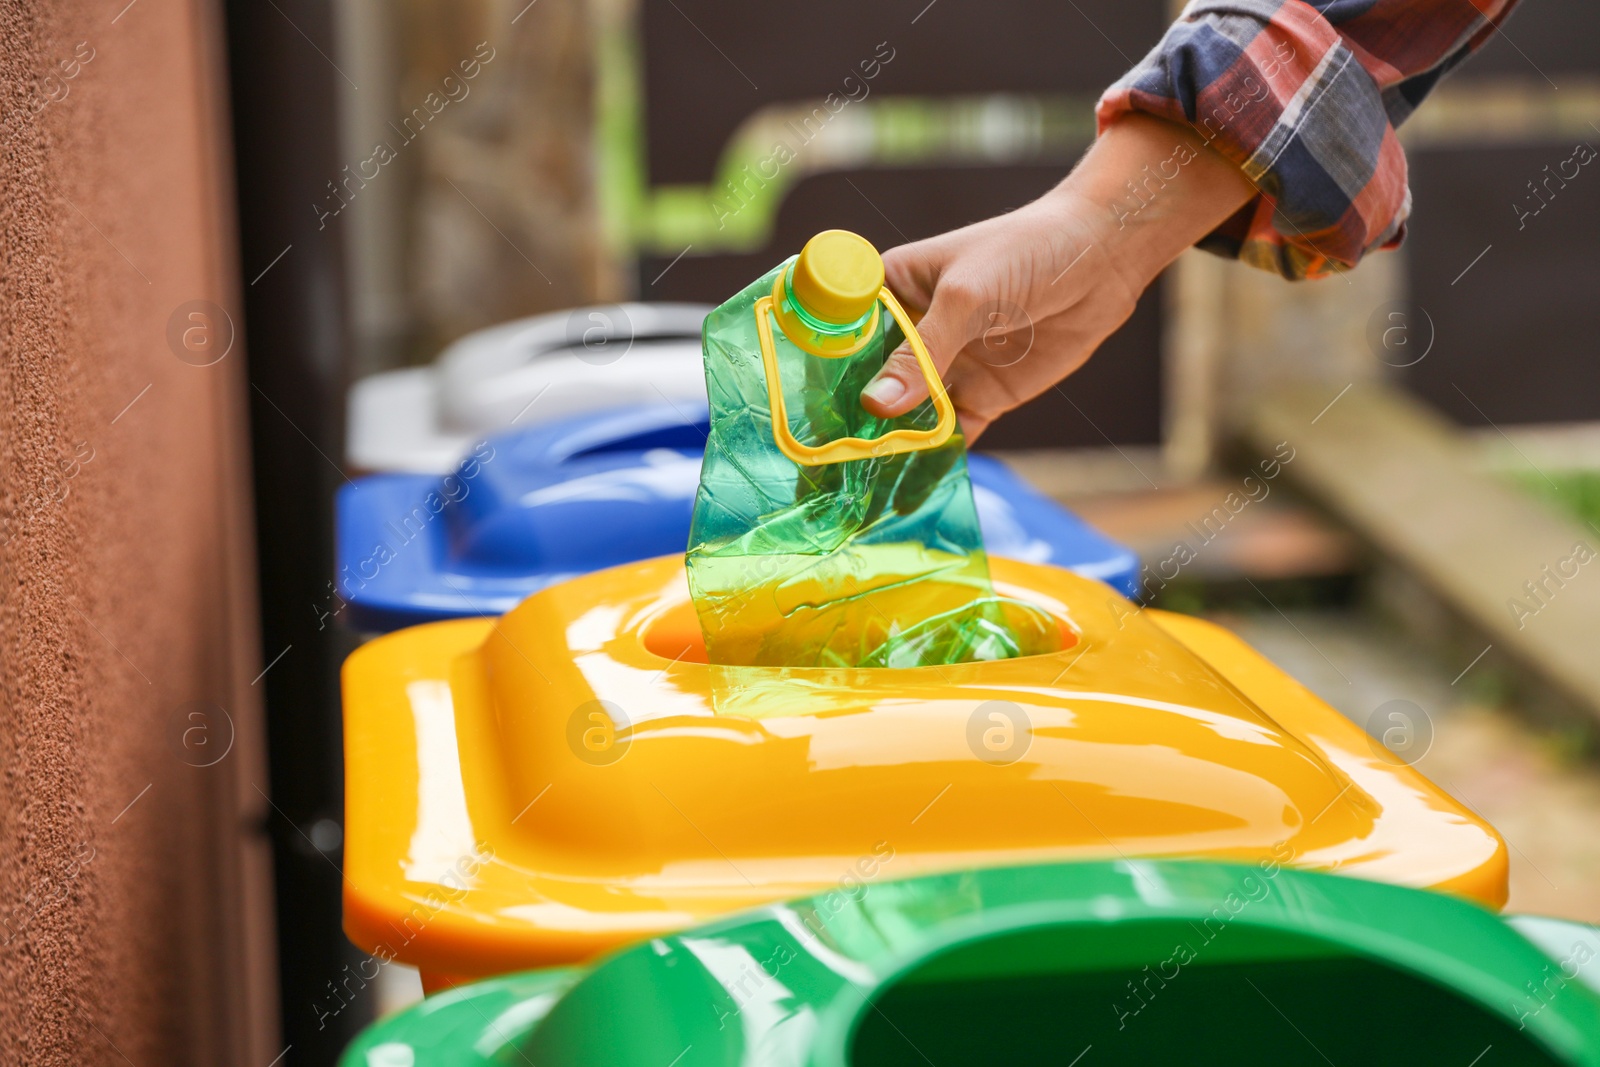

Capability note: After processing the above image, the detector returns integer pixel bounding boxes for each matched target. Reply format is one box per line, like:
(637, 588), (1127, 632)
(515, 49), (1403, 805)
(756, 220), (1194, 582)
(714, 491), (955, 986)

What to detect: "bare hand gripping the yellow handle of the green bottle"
(861, 114), (1254, 442)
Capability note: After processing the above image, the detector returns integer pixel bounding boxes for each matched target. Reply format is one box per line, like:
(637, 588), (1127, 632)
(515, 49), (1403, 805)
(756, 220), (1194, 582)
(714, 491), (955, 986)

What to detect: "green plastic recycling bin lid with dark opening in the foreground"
(342, 856), (1600, 1067)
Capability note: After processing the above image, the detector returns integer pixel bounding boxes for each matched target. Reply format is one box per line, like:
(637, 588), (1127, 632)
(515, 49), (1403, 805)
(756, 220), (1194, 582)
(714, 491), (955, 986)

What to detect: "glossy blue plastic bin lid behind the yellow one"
(334, 403), (1139, 632)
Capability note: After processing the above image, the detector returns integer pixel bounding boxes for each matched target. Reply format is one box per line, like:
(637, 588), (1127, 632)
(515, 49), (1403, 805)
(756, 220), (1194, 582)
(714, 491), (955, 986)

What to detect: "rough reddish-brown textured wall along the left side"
(0, 0), (280, 1067)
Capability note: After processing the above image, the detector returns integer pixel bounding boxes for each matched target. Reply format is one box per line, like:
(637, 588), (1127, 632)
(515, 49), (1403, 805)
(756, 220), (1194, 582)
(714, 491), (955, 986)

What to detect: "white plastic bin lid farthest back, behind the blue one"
(346, 304), (710, 474)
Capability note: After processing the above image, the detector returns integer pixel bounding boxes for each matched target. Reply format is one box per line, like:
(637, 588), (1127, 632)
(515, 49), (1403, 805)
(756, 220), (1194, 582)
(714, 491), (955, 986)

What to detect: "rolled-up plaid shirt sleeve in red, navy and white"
(1096, 0), (1517, 278)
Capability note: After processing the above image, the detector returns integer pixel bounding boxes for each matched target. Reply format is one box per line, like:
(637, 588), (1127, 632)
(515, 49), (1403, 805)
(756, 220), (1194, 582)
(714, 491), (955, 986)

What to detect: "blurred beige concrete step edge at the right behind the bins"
(1240, 382), (1600, 720)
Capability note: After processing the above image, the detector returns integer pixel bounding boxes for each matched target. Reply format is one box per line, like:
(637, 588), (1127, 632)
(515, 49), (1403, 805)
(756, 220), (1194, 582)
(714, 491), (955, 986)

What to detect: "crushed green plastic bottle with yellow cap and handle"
(688, 230), (1053, 667)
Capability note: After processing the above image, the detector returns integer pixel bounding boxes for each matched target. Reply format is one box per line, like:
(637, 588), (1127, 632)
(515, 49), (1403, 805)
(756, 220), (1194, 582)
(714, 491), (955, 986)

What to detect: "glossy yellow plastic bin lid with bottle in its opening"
(344, 557), (1507, 984)
